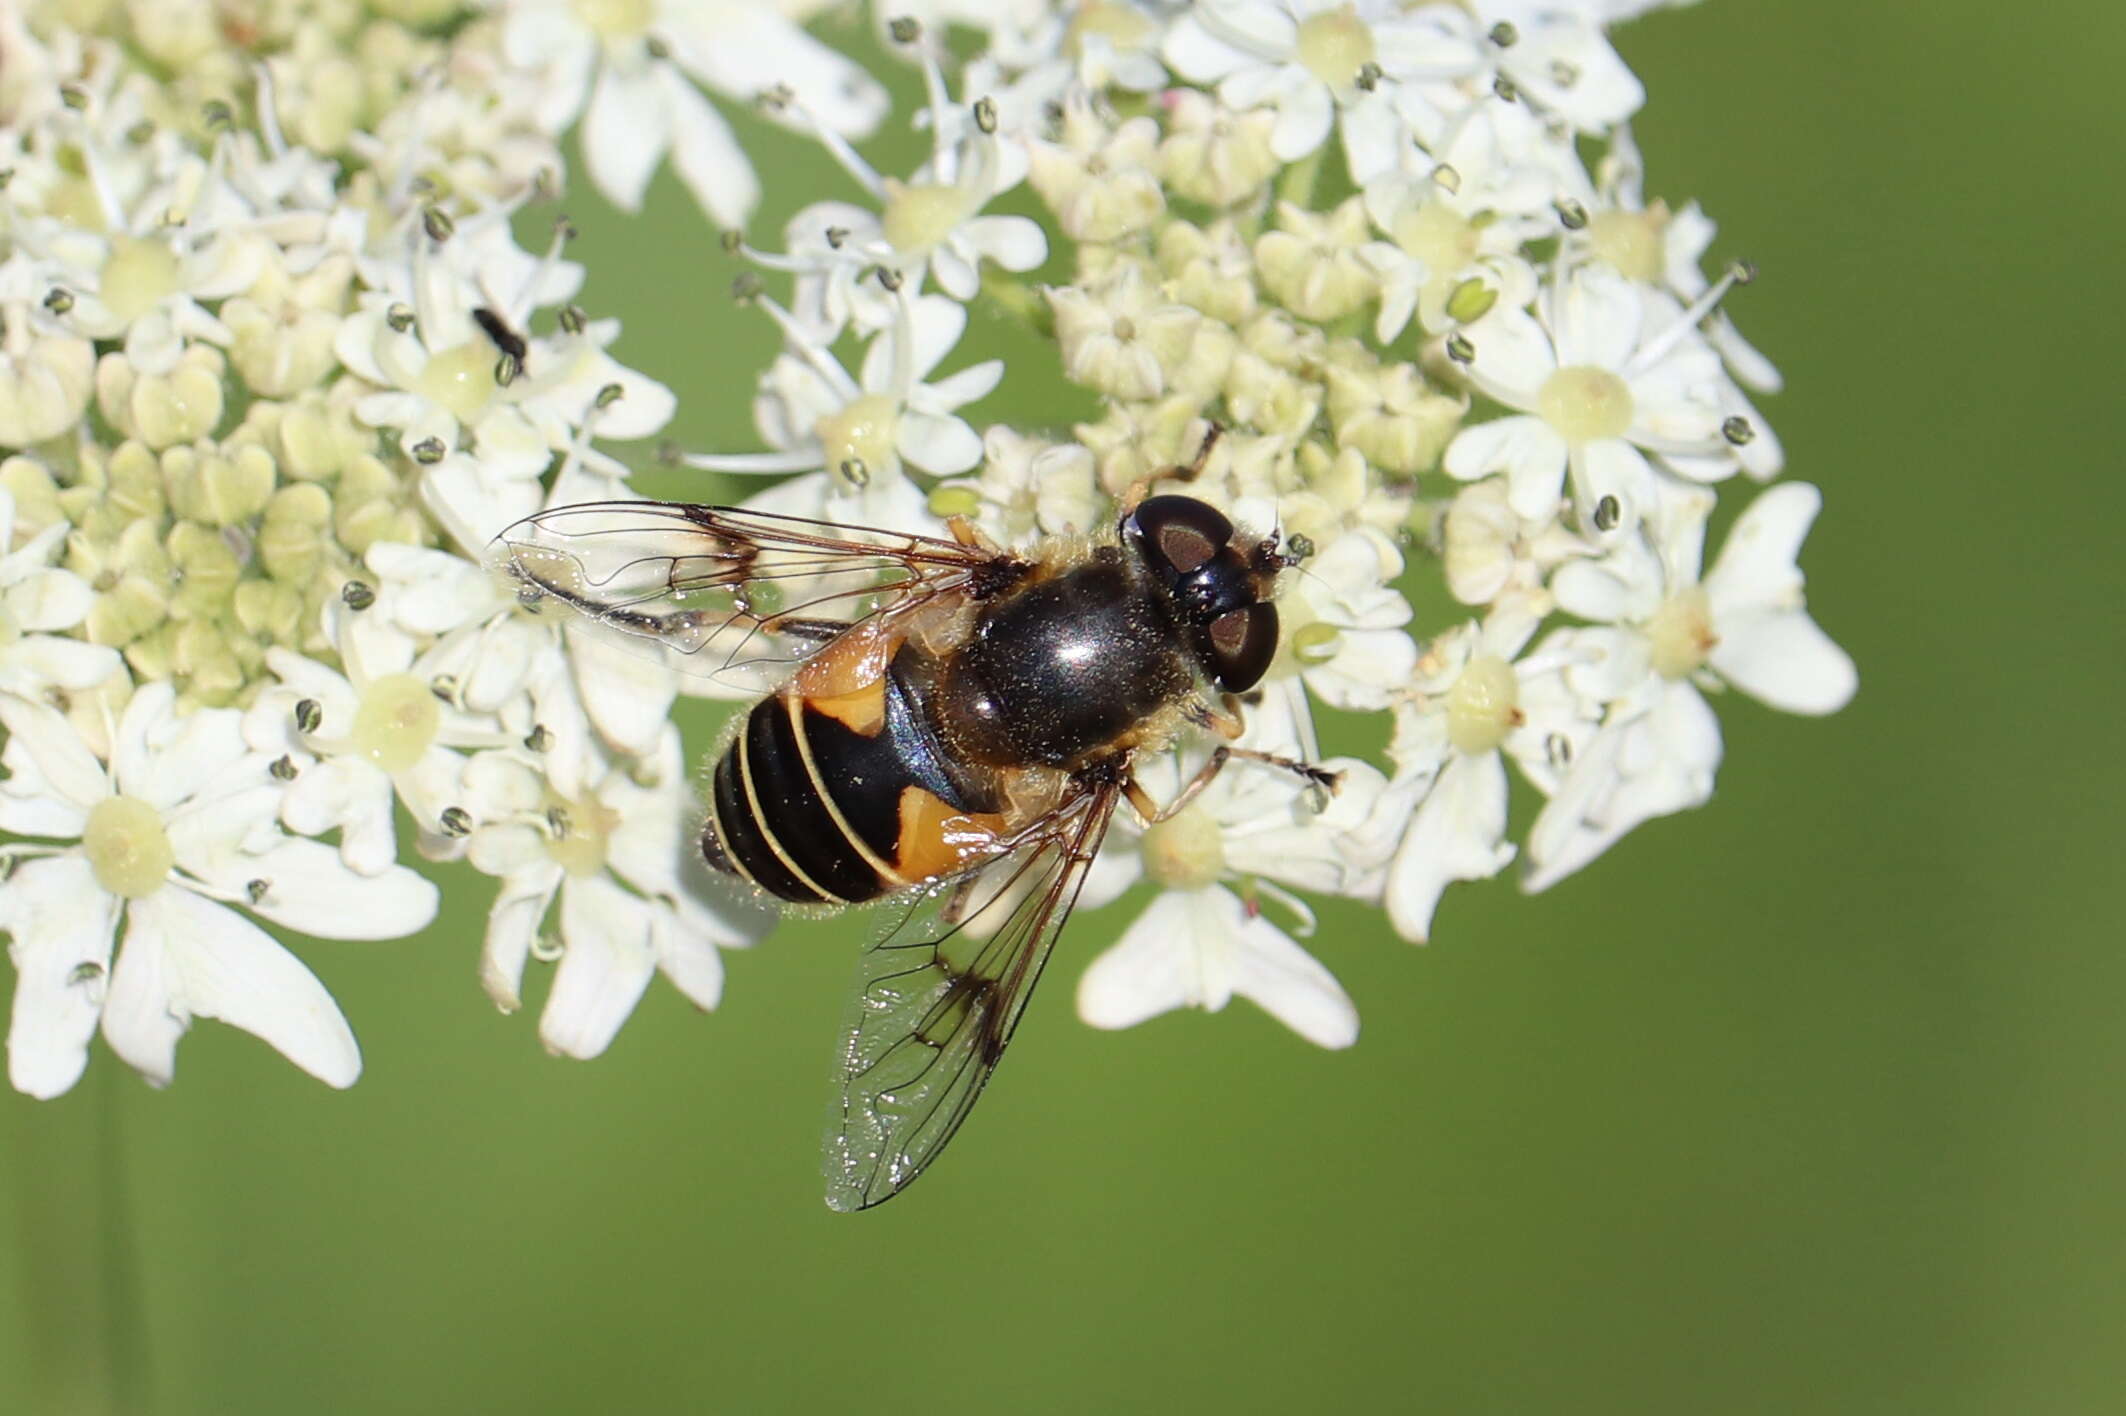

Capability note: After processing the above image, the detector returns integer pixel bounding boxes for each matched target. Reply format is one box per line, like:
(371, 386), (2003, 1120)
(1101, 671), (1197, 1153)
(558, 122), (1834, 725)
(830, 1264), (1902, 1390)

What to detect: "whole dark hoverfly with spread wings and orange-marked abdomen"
(497, 457), (1335, 1210)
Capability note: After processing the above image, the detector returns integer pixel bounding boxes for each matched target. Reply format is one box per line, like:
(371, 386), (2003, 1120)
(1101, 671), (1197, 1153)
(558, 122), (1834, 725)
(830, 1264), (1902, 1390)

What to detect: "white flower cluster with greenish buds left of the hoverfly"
(0, 0), (782, 1097)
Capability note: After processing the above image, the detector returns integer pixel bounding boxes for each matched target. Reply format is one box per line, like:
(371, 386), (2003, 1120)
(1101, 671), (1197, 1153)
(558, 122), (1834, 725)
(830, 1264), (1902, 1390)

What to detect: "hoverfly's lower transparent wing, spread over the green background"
(825, 787), (1123, 1210)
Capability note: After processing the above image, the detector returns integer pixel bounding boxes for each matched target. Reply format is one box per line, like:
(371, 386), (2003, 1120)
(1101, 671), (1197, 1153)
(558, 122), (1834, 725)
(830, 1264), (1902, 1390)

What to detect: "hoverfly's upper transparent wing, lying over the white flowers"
(489, 502), (1001, 691)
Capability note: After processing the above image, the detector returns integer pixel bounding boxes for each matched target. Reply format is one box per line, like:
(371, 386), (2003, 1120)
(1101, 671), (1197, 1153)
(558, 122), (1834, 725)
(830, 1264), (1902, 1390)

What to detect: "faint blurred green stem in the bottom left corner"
(6, 1057), (149, 1416)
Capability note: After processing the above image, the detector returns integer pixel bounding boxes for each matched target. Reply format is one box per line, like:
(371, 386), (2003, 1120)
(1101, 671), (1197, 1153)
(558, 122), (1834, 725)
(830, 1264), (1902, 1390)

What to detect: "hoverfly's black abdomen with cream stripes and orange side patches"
(702, 644), (1003, 904)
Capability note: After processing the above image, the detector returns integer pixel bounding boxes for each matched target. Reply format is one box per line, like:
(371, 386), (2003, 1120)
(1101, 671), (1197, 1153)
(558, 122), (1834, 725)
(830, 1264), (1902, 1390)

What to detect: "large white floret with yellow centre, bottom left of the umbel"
(0, 682), (438, 1097)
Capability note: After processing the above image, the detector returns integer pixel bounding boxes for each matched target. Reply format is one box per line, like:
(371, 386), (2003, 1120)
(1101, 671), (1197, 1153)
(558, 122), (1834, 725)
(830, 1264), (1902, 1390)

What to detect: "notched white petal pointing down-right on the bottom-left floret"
(104, 887), (361, 1086)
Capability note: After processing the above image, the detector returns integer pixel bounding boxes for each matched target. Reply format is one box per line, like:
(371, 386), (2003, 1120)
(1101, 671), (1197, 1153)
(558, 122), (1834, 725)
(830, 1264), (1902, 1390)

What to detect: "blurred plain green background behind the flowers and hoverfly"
(0, 0), (2126, 1416)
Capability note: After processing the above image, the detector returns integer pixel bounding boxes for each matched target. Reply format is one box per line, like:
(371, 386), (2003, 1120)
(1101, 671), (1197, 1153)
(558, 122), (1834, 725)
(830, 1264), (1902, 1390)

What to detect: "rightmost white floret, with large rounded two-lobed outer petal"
(1524, 483), (1858, 891)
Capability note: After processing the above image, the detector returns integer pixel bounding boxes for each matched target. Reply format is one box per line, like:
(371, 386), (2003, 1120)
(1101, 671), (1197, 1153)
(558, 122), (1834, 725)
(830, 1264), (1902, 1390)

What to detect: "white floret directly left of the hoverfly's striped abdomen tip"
(463, 714), (765, 1057)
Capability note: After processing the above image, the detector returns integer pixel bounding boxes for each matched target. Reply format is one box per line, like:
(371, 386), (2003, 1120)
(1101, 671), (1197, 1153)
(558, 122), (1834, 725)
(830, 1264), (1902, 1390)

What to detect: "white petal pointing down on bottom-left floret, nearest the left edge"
(0, 857), (119, 1097)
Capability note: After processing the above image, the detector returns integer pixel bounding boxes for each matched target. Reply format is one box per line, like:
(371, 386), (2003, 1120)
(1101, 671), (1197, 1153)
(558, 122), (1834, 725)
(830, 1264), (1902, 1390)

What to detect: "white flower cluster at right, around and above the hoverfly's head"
(691, 0), (1856, 1046)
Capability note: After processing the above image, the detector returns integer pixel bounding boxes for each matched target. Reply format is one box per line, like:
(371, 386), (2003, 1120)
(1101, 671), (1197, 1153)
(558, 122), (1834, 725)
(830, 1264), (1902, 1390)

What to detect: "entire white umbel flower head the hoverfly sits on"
(0, 0), (1856, 1095)
